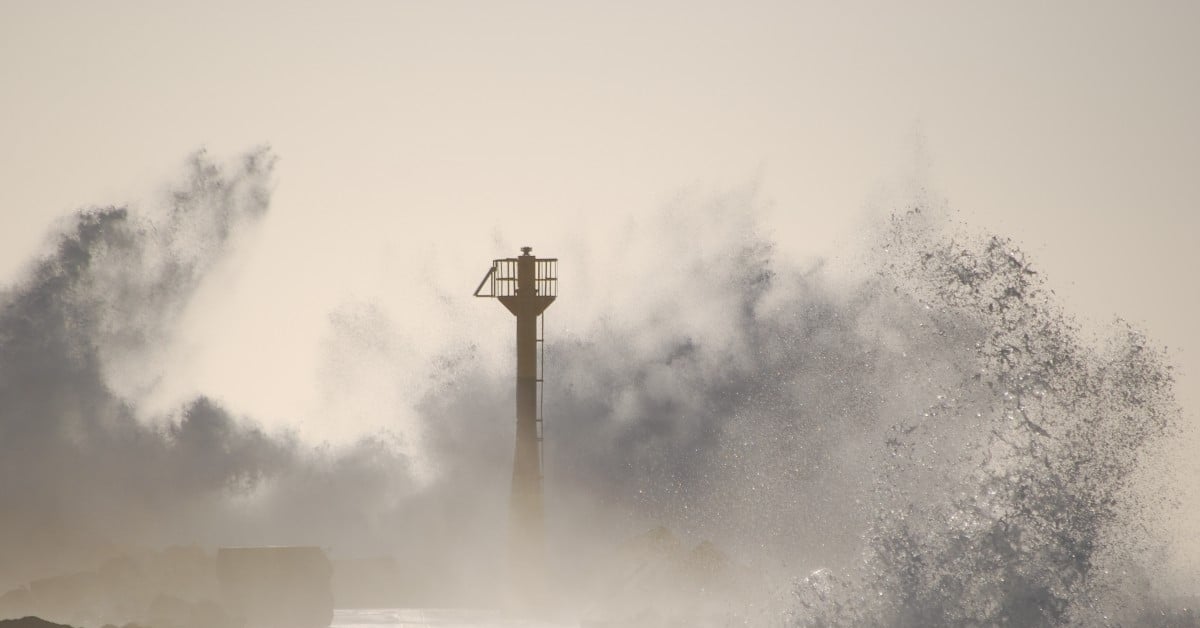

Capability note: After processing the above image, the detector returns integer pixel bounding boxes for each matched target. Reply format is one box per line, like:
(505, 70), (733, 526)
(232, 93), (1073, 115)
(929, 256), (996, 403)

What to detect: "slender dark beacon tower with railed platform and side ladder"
(475, 246), (558, 606)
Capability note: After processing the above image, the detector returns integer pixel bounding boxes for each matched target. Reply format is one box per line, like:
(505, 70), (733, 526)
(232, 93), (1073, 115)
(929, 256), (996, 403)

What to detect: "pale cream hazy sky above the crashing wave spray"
(0, 0), (1200, 540)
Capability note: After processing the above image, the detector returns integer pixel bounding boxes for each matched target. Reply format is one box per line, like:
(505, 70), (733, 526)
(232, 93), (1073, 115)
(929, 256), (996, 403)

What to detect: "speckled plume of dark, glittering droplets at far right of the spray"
(796, 209), (1178, 627)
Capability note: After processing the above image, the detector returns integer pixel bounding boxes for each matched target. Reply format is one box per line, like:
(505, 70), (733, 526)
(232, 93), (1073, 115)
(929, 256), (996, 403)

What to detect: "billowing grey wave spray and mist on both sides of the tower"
(0, 149), (1181, 626)
